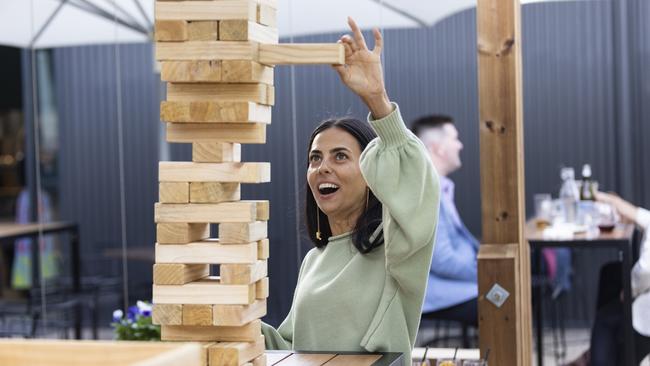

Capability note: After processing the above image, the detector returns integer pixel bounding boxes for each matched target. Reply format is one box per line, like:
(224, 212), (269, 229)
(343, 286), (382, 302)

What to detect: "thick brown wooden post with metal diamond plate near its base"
(470, 0), (532, 365)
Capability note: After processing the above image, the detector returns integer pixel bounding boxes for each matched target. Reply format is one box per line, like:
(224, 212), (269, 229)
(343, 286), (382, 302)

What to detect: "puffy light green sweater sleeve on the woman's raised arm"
(360, 105), (440, 297)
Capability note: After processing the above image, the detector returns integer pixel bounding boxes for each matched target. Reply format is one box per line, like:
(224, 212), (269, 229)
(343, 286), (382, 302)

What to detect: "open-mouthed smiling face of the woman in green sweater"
(307, 127), (366, 225)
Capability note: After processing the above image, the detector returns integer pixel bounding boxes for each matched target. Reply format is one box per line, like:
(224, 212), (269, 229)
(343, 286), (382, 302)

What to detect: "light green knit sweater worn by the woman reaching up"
(262, 103), (439, 364)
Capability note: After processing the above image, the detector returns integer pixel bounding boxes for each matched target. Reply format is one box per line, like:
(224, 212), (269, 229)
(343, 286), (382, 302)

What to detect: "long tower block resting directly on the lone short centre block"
(167, 123), (266, 144)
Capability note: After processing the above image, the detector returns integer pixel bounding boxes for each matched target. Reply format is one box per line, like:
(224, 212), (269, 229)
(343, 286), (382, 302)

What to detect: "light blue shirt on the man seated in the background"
(422, 177), (479, 313)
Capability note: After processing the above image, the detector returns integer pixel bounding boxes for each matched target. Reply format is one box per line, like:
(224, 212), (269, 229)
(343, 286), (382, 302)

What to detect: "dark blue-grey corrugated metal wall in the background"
(31, 0), (650, 323)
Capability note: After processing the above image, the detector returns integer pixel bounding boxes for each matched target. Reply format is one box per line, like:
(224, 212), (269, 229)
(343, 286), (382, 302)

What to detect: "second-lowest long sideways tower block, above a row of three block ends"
(153, 277), (256, 305)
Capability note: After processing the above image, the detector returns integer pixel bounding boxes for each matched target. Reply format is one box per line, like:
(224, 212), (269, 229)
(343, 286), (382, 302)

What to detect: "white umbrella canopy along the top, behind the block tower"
(0, 0), (576, 48)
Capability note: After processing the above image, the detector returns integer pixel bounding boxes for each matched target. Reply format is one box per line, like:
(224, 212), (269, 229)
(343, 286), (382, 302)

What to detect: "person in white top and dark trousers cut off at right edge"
(569, 192), (650, 366)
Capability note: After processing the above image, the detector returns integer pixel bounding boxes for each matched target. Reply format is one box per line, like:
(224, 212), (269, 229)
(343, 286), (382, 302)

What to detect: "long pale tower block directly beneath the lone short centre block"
(158, 161), (271, 184)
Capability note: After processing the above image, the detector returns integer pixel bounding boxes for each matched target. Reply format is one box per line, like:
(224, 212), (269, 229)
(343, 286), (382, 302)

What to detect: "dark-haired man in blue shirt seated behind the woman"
(411, 115), (479, 328)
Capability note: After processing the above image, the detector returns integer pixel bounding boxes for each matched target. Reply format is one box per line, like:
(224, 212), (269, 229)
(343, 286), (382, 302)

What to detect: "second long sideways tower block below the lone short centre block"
(155, 201), (269, 224)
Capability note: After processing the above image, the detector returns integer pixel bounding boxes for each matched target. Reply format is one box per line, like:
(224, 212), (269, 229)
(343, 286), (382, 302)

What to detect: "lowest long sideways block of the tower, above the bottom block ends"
(160, 322), (262, 342)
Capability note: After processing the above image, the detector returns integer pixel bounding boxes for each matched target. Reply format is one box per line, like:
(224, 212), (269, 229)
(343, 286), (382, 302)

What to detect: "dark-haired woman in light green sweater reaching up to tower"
(263, 19), (439, 362)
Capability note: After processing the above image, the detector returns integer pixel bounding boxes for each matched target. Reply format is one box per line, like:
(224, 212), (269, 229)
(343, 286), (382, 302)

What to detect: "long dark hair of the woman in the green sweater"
(305, 118), (384, 254)
